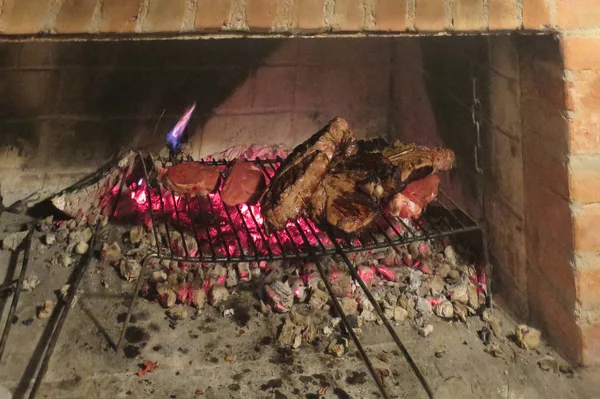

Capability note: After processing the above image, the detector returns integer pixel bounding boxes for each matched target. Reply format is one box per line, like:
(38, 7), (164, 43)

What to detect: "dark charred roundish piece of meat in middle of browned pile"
(309, 171), (379, 233)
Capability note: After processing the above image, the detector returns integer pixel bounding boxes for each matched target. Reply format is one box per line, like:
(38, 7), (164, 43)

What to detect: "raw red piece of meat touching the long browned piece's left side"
(221, 161), (266, 206)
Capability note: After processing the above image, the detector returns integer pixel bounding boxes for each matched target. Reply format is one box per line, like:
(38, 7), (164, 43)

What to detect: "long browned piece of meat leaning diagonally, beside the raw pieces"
(260, 118), (356, 230)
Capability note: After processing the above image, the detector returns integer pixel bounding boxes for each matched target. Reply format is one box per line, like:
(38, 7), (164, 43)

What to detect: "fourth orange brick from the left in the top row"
(143, 0), (187, 32)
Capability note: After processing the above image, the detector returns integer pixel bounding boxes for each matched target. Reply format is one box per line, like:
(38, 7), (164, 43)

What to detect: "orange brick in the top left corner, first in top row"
(2, 0), (48, 34)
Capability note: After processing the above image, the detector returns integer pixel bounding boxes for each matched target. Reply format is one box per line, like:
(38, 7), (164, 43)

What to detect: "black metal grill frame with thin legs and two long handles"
(113, 152), (491, 399)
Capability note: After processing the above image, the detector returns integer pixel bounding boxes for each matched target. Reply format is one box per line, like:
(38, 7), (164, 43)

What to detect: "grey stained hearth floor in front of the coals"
(0, 214), (600, 399)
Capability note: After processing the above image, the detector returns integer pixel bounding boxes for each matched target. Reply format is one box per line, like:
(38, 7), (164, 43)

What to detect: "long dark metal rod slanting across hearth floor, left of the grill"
(29, 224), (98, 399)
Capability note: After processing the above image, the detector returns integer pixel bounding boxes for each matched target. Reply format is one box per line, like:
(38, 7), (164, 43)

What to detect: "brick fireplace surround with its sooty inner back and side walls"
(0, 0), (600, 365)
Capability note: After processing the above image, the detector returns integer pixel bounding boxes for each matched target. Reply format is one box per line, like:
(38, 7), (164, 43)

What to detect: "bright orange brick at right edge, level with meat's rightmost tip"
(569, 155), (600, 203)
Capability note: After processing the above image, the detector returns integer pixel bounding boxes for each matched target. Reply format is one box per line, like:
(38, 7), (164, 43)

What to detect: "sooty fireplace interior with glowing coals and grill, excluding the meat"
(0, 35), (583, 395)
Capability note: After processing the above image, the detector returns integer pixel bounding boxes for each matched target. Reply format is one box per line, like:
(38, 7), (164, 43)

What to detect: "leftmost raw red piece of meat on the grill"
(158, 161), (221, 196)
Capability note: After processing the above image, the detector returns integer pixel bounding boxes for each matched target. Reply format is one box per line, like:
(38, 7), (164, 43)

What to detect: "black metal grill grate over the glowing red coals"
(115, 154), (479, 262)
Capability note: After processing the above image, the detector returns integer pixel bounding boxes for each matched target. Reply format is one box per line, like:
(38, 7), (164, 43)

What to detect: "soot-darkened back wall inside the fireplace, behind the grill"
(0, 38), (398, 203)
